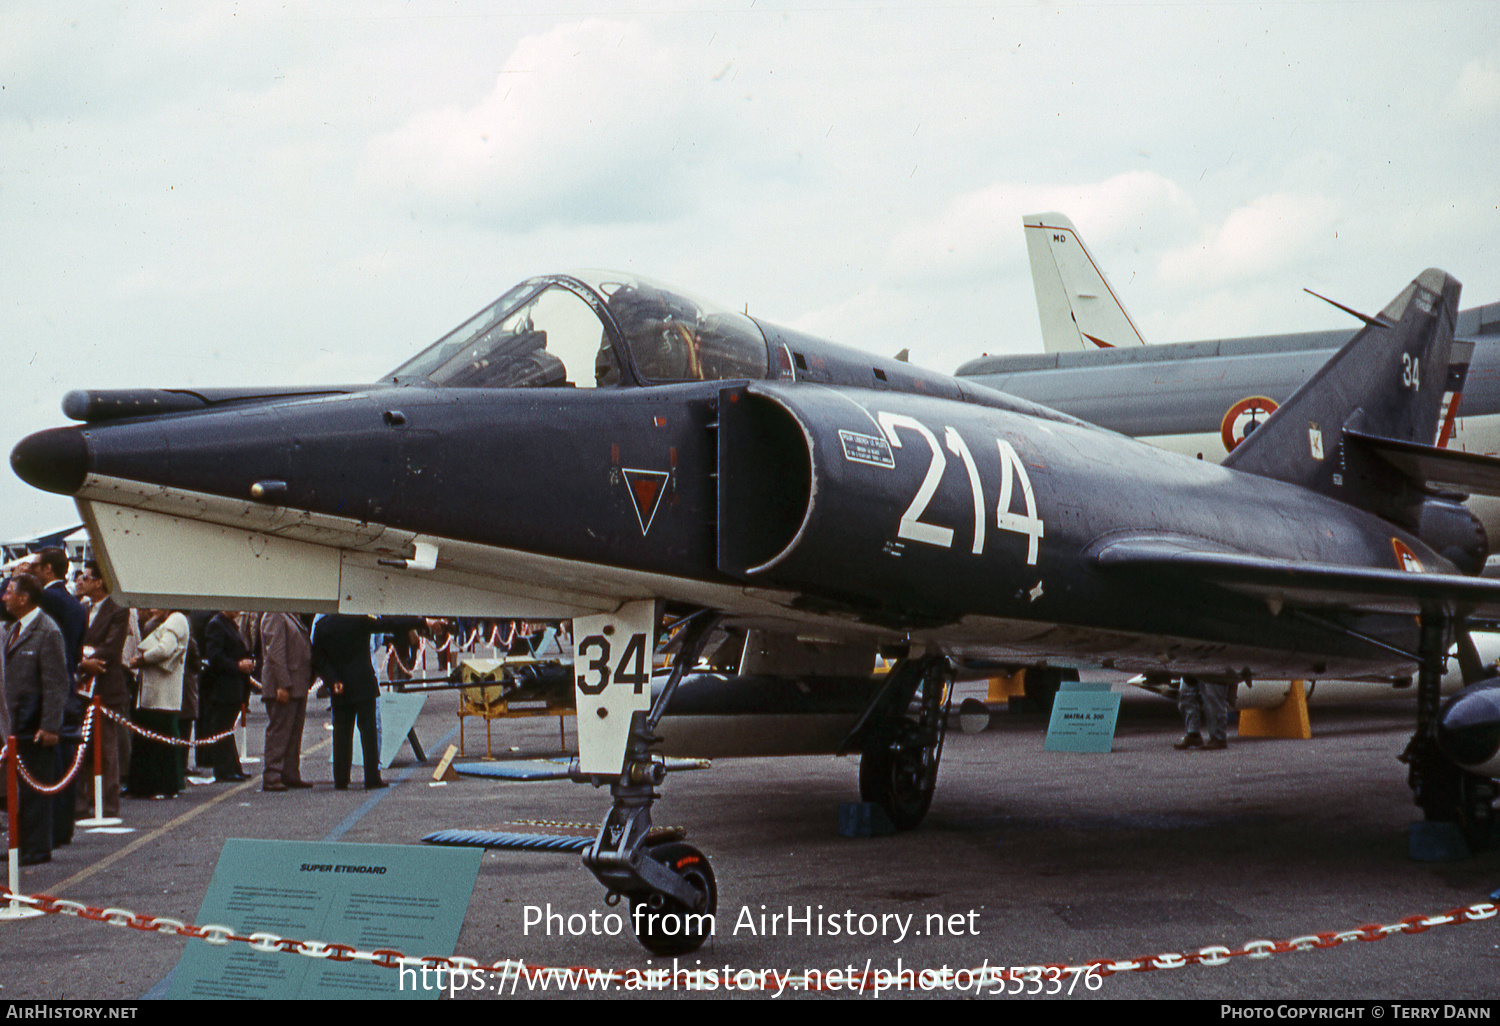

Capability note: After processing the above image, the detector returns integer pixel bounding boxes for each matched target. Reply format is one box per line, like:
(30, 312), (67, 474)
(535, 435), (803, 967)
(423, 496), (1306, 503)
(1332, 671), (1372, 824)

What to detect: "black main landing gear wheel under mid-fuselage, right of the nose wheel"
(860, 660), (948, 830)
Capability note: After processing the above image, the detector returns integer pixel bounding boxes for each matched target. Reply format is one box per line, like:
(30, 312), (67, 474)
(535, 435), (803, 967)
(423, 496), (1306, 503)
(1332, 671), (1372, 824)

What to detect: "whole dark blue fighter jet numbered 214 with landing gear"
(11, 270), (1500, 953)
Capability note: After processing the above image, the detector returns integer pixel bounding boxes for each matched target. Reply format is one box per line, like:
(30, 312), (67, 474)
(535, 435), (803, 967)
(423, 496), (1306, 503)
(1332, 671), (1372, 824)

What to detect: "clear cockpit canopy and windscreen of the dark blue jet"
(386, 272), (768, 389)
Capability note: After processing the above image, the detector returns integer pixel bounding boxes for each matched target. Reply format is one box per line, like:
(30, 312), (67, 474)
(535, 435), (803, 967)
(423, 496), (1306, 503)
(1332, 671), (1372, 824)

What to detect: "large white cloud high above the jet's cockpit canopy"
(366, 18), (732, 231)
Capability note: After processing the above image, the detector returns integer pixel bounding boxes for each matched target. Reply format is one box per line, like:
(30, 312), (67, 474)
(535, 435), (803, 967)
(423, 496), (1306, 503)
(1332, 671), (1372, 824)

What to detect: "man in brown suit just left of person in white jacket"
(75, 560), (131, 818)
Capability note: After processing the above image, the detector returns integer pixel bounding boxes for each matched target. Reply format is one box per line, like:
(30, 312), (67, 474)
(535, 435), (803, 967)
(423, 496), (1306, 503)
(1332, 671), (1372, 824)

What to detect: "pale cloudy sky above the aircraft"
(0, 0), (1500, 539)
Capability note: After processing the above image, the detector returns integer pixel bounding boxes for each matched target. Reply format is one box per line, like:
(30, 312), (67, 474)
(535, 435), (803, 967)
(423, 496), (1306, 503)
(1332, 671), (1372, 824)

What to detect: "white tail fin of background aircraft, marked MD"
(1022, 213), (1146, 353)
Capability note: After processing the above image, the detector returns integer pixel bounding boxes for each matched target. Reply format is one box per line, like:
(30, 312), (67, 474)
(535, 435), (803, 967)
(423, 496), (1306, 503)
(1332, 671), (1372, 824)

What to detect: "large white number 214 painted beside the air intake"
(878, 413), (1043, 566)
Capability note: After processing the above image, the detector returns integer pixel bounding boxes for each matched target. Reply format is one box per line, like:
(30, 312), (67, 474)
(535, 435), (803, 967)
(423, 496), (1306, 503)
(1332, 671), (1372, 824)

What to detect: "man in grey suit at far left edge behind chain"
(0, 575), (71, 866)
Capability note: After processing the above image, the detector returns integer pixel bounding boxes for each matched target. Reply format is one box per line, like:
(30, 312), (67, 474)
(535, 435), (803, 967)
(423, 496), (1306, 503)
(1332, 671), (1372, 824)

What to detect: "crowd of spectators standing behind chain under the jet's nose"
(0, 549), (566, 864)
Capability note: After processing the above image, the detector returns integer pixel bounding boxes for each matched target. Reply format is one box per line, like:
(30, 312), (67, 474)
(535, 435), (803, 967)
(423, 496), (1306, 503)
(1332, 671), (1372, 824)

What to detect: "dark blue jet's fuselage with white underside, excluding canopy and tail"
(20, 372), (1446, 677)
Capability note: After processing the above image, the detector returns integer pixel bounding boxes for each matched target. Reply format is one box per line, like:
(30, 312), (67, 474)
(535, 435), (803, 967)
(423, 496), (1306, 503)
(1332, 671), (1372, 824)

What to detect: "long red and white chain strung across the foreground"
(0, 888), (1500, 990)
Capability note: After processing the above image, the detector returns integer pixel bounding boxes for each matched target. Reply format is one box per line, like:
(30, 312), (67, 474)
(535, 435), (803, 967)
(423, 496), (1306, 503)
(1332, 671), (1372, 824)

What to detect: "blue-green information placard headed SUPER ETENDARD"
(167, 839), (483, 1001)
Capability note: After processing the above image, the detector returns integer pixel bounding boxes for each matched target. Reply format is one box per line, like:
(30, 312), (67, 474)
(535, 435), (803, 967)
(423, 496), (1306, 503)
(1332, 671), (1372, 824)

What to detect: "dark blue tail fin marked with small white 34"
(1224, 269), (1470, 521)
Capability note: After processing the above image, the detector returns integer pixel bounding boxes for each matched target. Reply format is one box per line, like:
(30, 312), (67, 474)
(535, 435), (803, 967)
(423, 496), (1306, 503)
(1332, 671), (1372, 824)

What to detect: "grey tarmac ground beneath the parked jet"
(0, 690), (1500, 1002)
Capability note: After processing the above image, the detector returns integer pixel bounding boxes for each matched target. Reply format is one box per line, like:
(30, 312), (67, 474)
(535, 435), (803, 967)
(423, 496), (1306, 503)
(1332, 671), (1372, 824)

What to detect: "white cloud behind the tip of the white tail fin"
(888, 171), (1193, 281)
